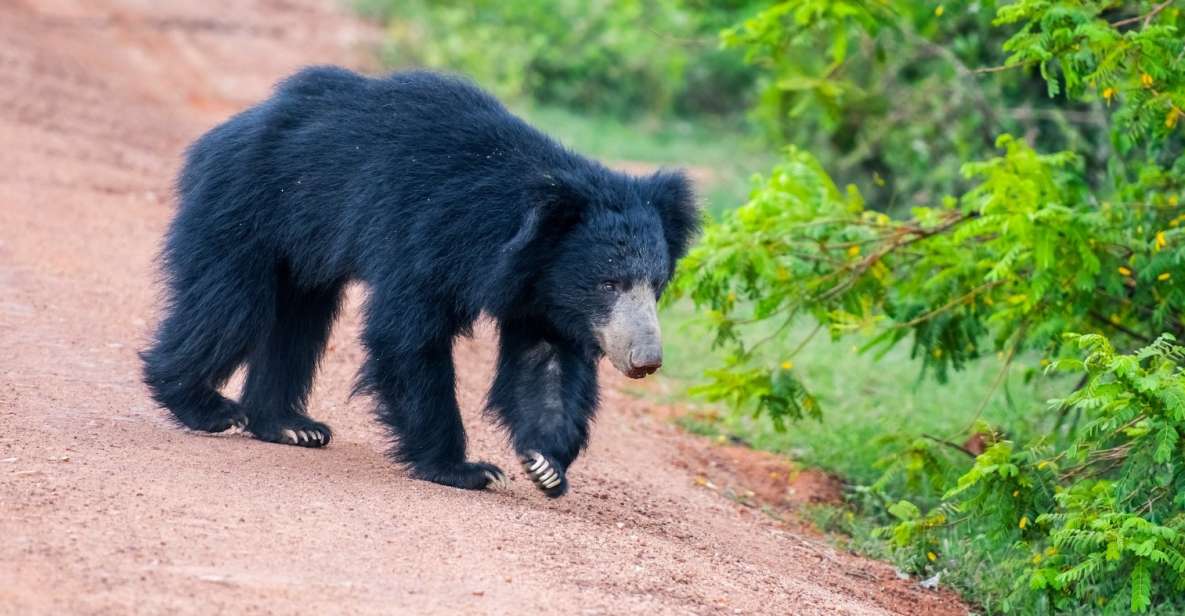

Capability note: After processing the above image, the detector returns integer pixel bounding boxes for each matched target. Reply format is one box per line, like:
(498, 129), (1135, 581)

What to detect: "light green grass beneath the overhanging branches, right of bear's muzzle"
(662, 302), (1064, 485)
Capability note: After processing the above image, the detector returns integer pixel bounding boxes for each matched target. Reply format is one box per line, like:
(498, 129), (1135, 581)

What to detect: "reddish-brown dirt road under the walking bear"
(0, 0), (963, 615)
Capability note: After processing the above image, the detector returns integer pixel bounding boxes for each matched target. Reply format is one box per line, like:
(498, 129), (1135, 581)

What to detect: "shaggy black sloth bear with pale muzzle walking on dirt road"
(141, 68), (698, 496)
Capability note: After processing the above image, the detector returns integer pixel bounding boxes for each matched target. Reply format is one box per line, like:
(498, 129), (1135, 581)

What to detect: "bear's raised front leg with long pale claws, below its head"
(489, 321), (597, 498)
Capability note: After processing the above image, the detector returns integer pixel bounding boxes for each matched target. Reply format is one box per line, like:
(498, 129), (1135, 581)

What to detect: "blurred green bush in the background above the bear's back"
(359, 0), (754, 117)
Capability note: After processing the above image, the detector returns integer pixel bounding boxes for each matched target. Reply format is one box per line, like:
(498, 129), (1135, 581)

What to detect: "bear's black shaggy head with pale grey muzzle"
(492, 167), (699, 378)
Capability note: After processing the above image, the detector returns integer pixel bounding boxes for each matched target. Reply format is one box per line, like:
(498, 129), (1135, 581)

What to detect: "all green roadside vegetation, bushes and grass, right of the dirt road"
(360, 0), (1185, 614)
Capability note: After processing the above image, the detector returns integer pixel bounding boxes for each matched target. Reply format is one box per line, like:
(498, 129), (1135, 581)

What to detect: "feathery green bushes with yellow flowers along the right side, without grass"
(672, 0), (1185, 614)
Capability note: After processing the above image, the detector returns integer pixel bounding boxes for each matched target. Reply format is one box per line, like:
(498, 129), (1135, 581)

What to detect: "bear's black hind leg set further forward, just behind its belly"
(242, 271), (342, 447)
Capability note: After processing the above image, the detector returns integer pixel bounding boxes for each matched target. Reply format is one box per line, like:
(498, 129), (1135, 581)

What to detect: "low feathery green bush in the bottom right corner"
(889, 334), (1185, 612)
